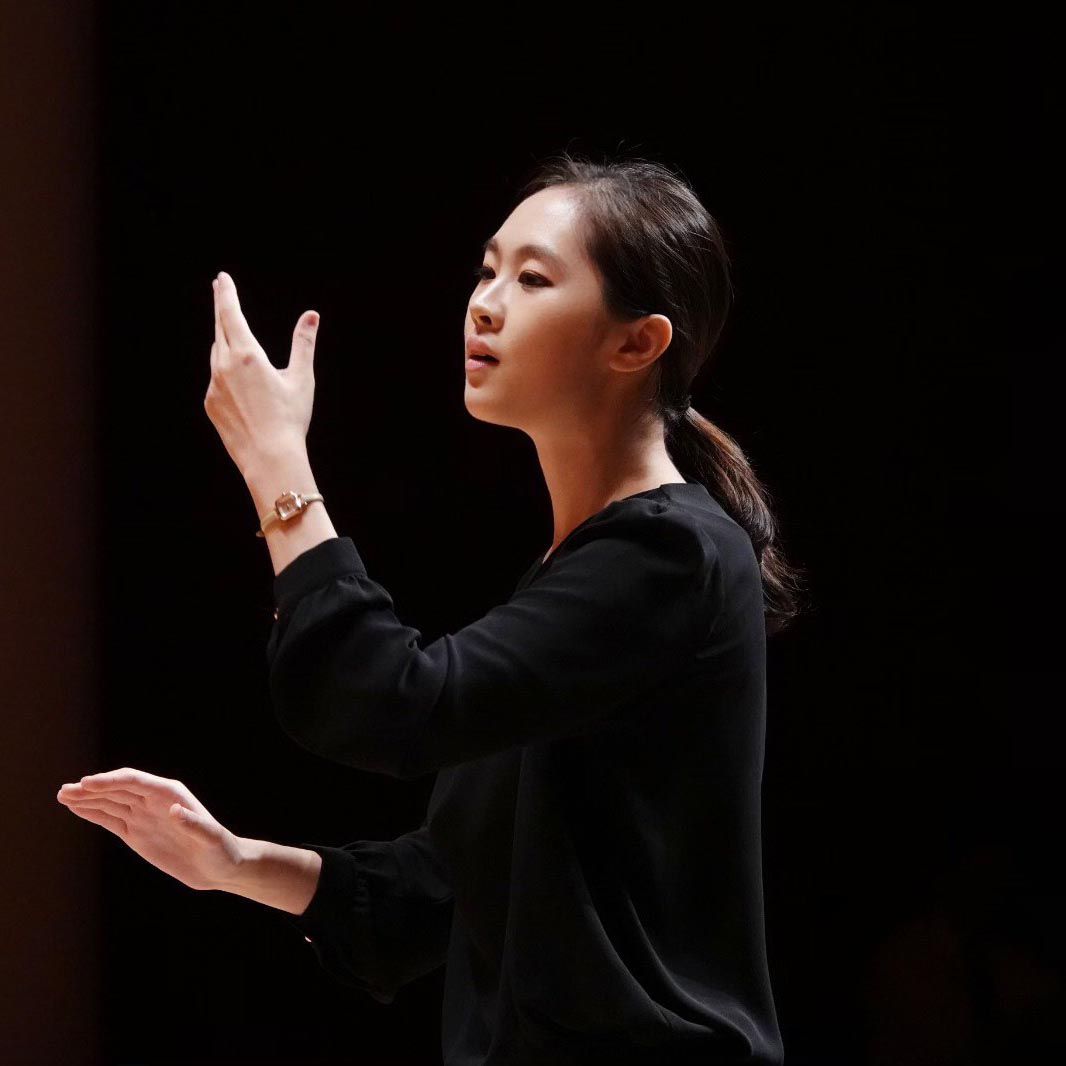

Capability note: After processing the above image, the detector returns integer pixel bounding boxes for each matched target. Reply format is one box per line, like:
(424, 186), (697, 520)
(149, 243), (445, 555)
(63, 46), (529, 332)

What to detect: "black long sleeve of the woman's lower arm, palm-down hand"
(288, 824), (453, 1003)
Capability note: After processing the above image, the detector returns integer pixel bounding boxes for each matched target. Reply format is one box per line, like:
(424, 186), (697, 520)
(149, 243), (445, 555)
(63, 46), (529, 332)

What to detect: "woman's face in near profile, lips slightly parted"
(464, 187), (618, 431)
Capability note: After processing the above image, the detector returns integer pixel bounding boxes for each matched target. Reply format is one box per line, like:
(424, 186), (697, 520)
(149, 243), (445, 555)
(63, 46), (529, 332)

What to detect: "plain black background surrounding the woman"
(5, 3), (1053, 1066)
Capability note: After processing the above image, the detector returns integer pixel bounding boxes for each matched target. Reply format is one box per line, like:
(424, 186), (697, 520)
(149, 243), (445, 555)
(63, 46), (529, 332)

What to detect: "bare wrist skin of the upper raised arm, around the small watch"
(243, 448), (337, 576)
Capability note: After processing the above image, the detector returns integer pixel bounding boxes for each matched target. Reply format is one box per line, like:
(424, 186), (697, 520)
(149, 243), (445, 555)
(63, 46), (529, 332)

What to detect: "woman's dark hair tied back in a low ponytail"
(519, 151), (804, 634)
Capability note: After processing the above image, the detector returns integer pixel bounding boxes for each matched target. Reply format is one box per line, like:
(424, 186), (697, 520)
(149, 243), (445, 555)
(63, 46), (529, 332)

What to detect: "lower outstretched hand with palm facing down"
(55, 766), (245, 890)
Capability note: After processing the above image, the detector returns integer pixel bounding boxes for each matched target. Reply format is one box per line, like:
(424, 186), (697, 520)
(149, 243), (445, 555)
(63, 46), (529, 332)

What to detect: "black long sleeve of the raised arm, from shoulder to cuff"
(267, 497), (716, 778)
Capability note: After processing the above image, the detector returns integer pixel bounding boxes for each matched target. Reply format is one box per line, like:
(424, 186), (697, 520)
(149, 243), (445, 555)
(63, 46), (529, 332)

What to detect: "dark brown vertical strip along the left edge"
(0, 0), (103, 1066)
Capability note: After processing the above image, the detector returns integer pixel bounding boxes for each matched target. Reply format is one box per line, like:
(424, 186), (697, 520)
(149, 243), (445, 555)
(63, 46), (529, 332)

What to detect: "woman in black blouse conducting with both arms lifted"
(59, 154), (798, 1066)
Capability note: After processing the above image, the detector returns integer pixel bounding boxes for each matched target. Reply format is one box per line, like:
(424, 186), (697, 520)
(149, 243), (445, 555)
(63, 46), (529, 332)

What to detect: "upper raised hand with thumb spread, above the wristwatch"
(204, 271), (319, 479)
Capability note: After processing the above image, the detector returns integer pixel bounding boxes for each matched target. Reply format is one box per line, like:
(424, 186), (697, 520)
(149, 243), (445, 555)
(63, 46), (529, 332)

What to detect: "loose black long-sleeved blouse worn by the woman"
(267, 482), (784, 1066)
